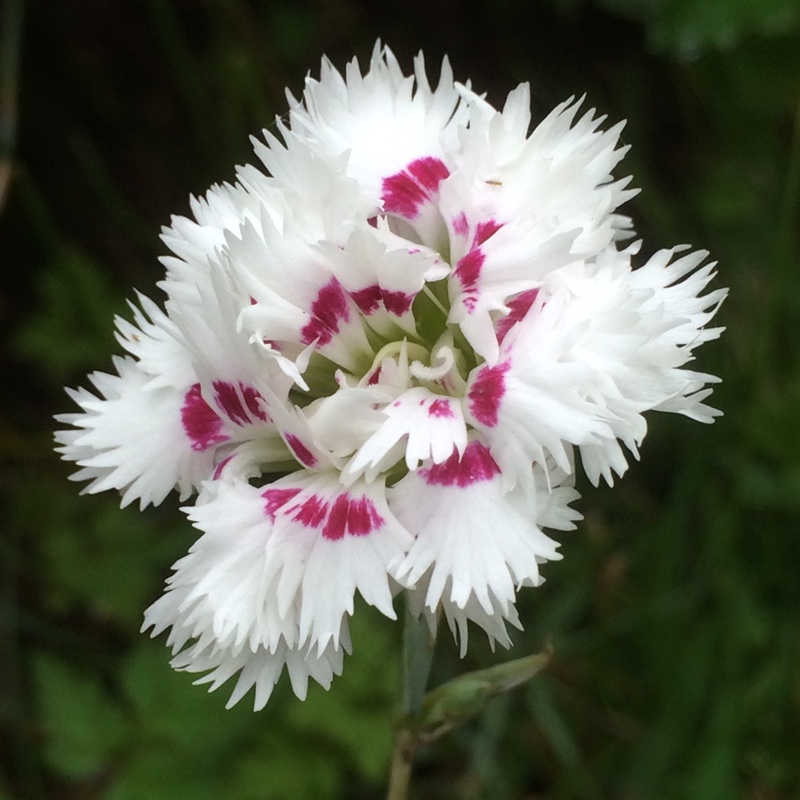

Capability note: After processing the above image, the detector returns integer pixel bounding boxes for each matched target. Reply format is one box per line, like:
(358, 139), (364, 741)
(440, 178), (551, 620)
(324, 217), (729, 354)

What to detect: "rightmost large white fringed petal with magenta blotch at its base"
(467, 242), (724, 483)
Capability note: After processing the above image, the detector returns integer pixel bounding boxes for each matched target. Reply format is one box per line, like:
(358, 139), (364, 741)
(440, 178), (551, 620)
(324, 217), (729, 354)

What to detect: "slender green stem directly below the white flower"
(387, 604), (436, 800)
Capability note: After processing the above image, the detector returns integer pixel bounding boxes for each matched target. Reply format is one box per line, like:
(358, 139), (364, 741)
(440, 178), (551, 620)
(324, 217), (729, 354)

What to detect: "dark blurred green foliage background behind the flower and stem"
(0, 0), (800, 800)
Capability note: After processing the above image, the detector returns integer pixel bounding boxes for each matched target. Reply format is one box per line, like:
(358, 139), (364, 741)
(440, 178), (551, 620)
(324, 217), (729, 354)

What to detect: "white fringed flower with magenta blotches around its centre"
(57, 46), (725, 708)
